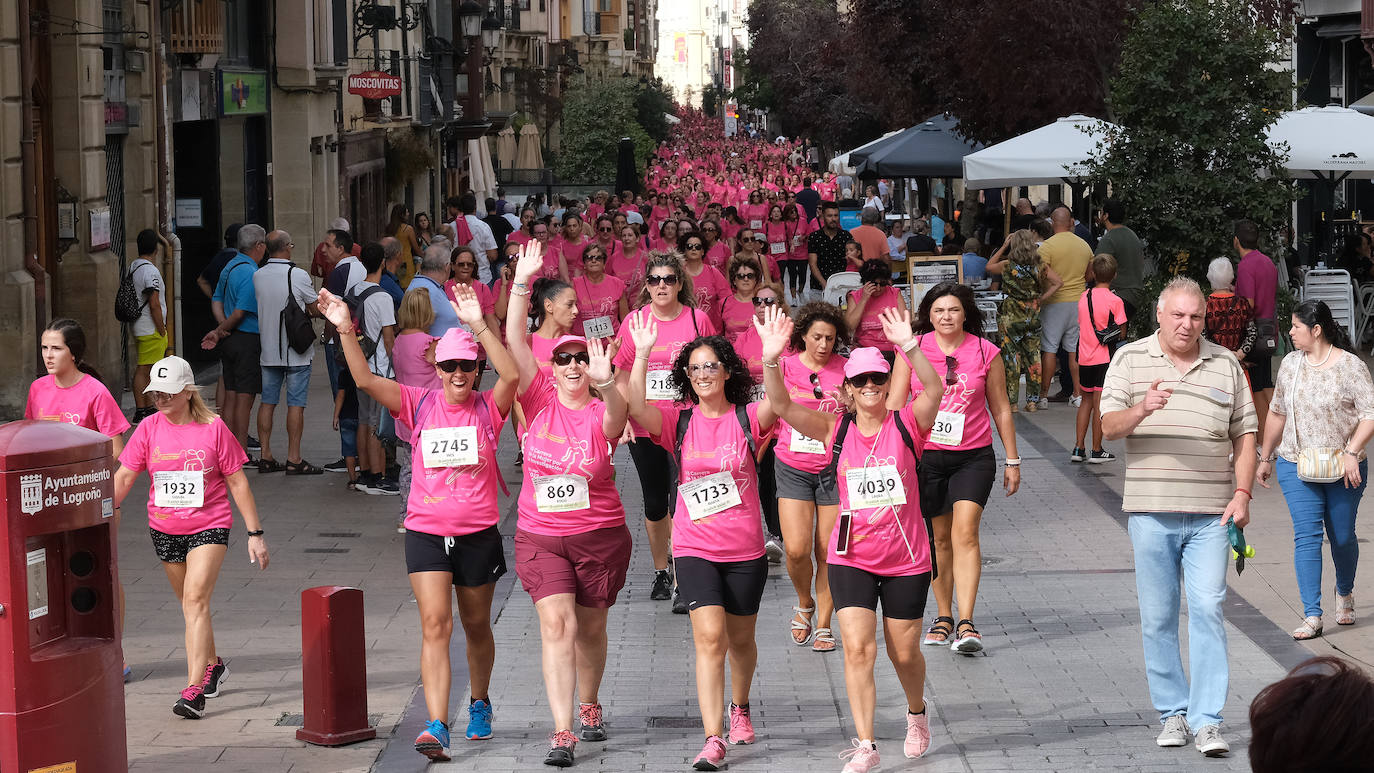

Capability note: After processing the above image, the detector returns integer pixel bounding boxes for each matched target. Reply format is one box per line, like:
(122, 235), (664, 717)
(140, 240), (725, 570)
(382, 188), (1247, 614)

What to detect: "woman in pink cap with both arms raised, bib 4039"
(760, 309), (941, 773)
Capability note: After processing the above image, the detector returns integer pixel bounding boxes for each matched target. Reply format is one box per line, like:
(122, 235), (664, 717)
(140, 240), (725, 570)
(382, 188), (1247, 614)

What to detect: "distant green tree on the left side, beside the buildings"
(554, 78), (655, 184)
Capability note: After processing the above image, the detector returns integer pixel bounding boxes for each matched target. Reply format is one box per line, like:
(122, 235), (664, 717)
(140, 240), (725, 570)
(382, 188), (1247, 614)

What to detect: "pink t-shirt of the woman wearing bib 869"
(519, 373), (625, 537)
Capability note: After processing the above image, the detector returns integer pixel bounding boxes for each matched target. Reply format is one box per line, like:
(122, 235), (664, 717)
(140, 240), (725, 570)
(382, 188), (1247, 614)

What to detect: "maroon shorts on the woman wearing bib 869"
(515, 524), (633, 610)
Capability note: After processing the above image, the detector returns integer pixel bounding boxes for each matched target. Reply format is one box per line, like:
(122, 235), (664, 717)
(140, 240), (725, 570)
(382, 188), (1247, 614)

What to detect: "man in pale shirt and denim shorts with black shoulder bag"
(253, 231), (324, 475)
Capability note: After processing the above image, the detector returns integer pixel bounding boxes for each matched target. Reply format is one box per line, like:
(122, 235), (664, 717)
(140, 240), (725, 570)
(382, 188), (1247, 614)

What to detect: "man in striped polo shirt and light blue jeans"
(1102, 277), (1259, 757)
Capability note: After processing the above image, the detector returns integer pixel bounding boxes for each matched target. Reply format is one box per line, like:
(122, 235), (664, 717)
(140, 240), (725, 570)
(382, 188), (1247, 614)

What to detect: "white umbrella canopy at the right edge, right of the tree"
(1267, 104), (1374, 184)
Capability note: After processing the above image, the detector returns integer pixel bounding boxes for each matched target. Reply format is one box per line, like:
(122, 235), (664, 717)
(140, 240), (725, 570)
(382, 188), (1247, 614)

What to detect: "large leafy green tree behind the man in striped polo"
(1091, 0), (1293, 277)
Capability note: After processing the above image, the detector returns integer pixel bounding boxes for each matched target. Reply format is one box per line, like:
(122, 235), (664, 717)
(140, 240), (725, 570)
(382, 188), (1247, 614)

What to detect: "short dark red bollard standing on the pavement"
(295, 585), (376, 746)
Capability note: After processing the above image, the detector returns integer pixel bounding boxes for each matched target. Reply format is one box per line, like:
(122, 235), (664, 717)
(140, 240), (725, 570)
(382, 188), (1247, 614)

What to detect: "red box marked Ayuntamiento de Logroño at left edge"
(0, 422), (129, 773)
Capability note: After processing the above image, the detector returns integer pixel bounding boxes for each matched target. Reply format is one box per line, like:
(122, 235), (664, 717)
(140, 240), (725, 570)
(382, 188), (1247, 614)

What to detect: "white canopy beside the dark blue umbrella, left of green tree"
(963, 115), (1114, 188)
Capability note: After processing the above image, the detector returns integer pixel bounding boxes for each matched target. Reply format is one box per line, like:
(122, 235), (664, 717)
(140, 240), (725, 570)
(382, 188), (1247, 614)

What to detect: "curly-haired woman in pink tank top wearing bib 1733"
(627, 317), (776, 770)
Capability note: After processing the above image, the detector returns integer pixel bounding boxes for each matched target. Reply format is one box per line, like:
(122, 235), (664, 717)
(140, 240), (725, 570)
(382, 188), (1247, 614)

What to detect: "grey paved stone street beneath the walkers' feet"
(120, 365), (1374, 773)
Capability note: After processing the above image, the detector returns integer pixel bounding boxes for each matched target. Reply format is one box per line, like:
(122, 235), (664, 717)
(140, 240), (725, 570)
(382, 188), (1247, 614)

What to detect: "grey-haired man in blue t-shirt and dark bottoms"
(201, 222), (267, 453)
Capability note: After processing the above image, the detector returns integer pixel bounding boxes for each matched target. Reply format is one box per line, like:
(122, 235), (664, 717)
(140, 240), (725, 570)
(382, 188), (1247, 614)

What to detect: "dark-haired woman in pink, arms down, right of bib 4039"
(916, 281), (1021, 654)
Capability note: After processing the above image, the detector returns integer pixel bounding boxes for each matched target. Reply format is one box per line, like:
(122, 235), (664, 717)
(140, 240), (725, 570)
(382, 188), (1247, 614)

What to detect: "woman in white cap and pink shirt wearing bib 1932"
(114, 354), (267, 719)
